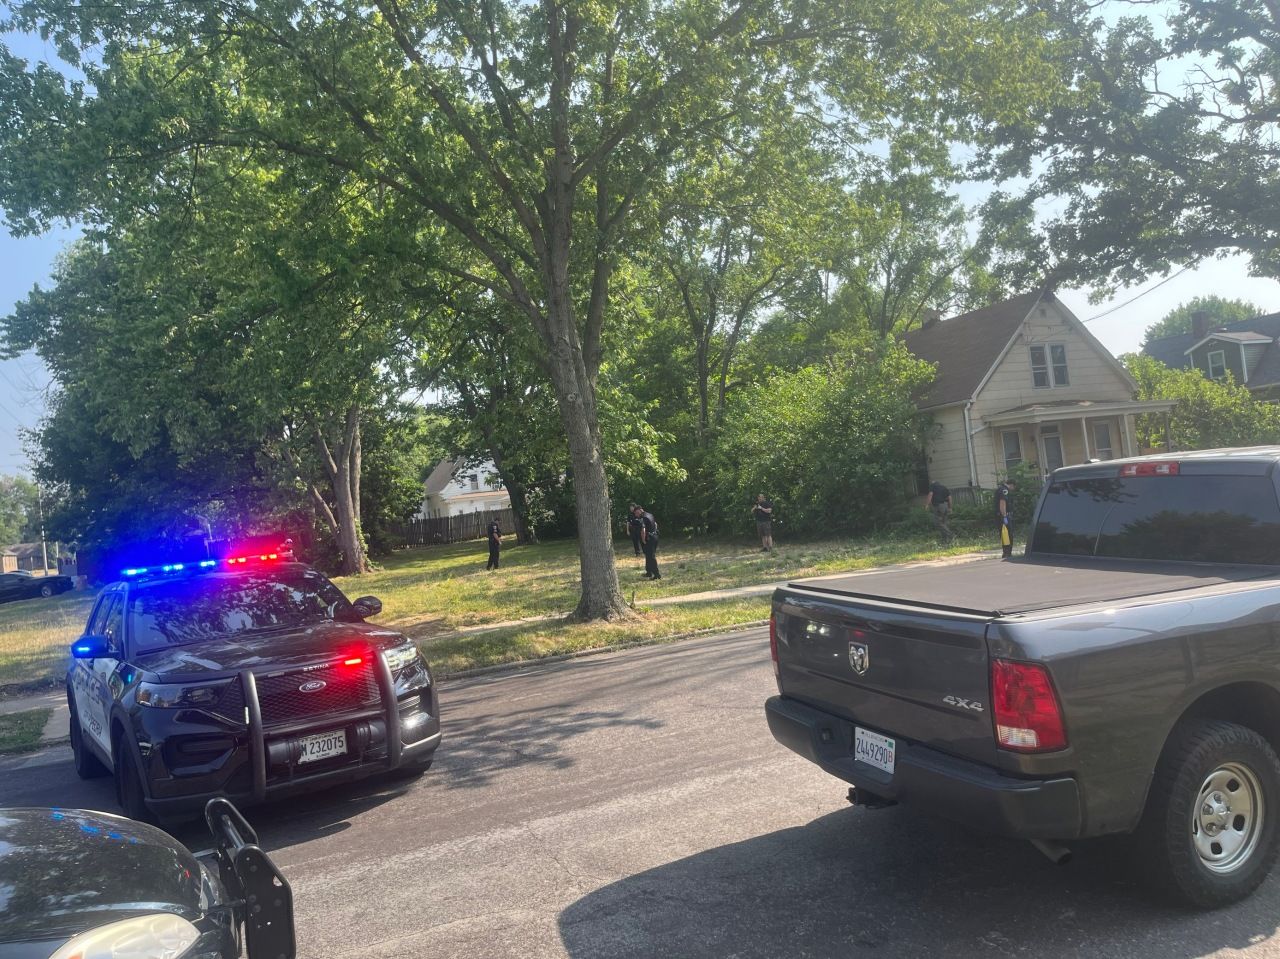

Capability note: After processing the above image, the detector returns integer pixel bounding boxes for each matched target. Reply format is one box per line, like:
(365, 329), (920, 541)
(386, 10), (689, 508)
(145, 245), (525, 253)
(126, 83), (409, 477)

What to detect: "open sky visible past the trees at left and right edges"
(0, 14), (1280, 474)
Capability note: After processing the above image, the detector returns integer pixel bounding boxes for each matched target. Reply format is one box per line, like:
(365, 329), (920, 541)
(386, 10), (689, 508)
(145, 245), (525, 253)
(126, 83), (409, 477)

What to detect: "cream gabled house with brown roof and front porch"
(906, 291), (1174, 489)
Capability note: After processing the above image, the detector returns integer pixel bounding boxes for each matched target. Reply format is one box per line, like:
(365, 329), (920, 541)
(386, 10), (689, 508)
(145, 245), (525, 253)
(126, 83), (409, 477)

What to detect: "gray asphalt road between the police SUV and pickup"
(0, 630), (1280, 959)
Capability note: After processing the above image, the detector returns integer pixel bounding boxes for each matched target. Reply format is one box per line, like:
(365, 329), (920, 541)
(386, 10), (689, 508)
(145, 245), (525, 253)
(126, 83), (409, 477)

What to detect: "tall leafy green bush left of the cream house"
(713, 344), (933, 535)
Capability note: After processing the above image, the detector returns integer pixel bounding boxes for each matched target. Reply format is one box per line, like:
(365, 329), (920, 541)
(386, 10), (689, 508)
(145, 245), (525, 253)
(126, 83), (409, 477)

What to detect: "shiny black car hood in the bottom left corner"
(0, 809), (200, 955)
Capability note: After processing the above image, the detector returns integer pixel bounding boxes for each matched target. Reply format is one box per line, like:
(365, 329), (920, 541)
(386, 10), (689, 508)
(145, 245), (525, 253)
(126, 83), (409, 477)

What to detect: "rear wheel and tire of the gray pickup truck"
(1138, 720), (1280, 909)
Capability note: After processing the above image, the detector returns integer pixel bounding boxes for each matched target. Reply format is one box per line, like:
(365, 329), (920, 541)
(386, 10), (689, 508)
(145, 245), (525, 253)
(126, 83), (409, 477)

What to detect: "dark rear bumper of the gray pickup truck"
(764, 697), (1080, 840)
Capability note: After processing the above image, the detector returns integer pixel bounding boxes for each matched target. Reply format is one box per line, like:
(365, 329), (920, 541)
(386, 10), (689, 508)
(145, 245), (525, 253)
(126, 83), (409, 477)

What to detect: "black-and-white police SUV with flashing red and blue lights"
(67, 553), (440, 819)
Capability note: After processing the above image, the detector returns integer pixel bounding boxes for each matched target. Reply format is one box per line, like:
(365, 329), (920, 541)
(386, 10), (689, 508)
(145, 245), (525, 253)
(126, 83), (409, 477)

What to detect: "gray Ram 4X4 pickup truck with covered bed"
(765, 448), (1280, 908)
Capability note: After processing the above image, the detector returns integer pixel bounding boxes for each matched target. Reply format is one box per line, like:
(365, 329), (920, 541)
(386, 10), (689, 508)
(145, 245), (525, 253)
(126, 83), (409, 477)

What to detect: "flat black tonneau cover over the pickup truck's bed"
(790, 556), (1280, 616)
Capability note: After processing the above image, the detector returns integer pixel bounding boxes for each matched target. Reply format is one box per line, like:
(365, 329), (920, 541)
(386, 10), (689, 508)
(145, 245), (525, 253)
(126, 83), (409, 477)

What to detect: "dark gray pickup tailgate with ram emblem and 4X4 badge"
(773, 588), (996, 763)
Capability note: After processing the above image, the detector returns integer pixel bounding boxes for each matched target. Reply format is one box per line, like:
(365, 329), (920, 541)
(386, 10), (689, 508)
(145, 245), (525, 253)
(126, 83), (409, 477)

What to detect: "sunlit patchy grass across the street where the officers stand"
(0, 538), (991, 691)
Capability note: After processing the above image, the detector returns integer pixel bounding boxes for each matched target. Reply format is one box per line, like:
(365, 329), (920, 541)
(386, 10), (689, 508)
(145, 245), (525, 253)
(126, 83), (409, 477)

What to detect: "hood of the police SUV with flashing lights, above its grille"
(137, 621), (408, 681)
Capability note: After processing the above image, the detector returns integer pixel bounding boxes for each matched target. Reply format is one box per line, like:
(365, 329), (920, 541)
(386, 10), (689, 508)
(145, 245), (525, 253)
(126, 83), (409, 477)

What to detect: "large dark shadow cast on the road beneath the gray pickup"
(559, 808), (1280, 959)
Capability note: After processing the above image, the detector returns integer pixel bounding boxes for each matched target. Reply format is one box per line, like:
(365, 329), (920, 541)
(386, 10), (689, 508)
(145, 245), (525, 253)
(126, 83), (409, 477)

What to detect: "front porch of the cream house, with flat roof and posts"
(975, 399), (1174, 485)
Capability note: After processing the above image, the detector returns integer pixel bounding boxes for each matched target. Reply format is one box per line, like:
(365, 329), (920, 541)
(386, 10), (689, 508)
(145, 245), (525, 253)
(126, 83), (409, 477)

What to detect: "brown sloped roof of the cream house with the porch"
(904, 291), (1043, 408)
